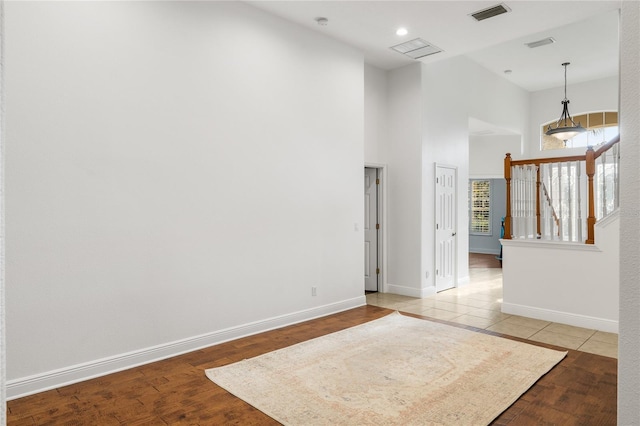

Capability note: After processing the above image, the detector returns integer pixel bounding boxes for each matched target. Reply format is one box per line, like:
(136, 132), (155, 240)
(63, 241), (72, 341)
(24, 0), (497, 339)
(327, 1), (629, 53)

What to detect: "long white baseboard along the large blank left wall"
(6, 295), (367, 400)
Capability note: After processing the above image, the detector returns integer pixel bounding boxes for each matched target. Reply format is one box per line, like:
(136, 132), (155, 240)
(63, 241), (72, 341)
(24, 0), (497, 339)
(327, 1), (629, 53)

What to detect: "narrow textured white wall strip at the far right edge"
(618, 1), (640, 425)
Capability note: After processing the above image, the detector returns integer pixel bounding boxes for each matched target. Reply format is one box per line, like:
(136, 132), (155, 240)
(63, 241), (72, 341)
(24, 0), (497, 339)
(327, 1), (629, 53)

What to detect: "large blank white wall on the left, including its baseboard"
(5, 2), (364, 396)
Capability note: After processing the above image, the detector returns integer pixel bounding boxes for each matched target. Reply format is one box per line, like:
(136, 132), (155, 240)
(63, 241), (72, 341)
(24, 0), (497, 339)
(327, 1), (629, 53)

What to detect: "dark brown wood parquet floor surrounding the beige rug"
(7, 306), (617, 426)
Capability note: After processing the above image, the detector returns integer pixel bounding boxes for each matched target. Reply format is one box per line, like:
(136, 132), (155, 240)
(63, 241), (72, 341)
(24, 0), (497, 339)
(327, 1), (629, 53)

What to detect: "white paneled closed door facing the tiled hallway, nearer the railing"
(435, 165), (457, 291)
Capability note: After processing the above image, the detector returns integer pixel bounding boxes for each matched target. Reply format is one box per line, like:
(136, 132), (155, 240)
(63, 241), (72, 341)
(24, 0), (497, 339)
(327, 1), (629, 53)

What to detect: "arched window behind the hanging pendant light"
(540, 111), (619, 151)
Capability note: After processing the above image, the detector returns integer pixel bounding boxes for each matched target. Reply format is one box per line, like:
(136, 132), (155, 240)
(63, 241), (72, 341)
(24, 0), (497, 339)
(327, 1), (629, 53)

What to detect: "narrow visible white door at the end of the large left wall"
(364, 167), (379, 291)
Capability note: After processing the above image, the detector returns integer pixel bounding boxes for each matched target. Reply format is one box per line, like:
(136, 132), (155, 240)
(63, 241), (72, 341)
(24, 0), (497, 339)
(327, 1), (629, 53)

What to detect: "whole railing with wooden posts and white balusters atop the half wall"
(504, 135), (620, 244)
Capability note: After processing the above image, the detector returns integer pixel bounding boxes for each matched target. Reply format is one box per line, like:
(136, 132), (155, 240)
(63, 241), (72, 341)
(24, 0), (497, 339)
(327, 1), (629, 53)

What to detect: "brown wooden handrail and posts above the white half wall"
(503, 135), (620, 244)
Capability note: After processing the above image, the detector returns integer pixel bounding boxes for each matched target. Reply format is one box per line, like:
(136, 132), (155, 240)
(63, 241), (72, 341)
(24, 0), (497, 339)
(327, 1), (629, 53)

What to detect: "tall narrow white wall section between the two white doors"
(386, 64), (422, 297)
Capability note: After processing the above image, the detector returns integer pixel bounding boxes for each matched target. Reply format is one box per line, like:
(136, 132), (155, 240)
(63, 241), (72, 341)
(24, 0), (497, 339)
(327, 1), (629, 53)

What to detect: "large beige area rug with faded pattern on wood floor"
(206, 312), (567, 426)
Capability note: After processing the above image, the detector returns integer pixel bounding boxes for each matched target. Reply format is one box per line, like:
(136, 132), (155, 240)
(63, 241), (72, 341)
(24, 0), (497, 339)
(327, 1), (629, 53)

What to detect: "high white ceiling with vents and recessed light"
(248, 0), (620, 91)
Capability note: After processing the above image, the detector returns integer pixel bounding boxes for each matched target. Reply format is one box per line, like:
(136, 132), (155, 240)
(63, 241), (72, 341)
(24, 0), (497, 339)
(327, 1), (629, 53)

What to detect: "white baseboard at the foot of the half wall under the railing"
(502, 302), (618, 333)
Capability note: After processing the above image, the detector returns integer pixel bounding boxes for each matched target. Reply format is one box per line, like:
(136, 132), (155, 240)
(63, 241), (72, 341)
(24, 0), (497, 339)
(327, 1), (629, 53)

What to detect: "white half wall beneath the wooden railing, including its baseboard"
(502, 214), (620, 333)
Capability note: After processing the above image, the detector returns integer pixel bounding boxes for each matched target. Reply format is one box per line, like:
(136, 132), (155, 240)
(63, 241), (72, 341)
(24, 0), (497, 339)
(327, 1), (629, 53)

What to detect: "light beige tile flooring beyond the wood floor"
(367, 268), (618, 358)
